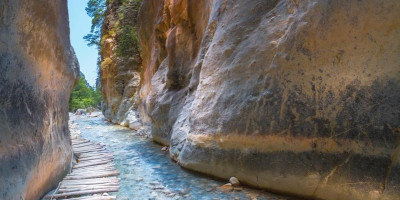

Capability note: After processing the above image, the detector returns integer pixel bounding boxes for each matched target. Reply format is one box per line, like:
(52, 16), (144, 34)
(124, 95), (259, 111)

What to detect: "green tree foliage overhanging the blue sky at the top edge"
(83, 0), (107, 46)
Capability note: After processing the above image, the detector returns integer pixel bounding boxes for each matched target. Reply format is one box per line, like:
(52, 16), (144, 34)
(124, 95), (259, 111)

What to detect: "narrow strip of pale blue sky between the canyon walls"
(68, 0), (97, 86)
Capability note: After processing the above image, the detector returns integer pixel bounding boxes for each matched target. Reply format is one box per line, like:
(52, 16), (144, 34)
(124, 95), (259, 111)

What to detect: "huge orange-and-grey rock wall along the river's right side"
(137, 0), (400, 199)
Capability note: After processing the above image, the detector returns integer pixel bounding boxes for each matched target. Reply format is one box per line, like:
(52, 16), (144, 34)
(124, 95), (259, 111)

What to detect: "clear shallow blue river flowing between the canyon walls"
(72, 115), (293, 200)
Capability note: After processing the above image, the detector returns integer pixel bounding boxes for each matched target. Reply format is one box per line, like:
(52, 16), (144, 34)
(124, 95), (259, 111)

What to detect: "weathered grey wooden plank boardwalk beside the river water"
(46, 136), (120, 200)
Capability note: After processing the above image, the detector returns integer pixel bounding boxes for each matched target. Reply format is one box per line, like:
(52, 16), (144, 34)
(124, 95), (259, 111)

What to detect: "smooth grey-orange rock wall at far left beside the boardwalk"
(0, 0), (79, 200)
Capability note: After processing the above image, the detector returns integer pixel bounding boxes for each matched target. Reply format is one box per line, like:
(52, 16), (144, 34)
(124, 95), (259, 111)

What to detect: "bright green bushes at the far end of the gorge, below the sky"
(69, 76), (101, 111)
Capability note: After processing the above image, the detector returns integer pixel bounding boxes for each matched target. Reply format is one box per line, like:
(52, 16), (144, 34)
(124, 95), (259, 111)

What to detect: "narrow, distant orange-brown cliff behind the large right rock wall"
(101, 0), (141, 127)
